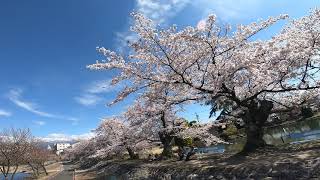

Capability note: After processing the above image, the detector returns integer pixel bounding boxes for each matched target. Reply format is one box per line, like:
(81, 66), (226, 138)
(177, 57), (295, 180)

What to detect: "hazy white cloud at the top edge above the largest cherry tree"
(116, 0), (263, 53)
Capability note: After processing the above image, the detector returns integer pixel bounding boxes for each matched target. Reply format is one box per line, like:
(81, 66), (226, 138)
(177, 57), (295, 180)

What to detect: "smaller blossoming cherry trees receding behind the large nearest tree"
(67, 89), (223, 162)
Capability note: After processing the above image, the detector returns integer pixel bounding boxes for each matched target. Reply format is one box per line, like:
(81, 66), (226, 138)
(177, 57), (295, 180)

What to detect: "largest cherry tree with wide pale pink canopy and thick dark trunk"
(88, 10), (320, 151)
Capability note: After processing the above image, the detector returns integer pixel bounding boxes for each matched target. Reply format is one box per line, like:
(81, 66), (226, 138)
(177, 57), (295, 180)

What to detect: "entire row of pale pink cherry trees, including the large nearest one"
(69, 9), (320, 160)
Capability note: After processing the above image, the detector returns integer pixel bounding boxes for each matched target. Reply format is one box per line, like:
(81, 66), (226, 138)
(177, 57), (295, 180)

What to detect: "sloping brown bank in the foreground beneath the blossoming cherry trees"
(76, 141), (320, 179)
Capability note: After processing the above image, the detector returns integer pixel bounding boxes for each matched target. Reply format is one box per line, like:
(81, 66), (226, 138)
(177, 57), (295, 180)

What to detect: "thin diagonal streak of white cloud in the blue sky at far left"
(8, 89), (79, 125)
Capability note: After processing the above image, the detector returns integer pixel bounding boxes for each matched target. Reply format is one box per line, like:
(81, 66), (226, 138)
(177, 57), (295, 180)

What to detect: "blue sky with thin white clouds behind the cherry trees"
(0, 0), (320, 139)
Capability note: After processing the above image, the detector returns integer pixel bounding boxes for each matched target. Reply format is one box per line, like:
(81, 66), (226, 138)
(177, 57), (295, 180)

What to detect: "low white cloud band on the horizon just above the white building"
(39, 132), (94, 142)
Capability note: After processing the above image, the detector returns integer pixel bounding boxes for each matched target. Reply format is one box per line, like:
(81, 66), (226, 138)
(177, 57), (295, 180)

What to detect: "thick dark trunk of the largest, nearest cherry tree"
(242, 100), (273, 153)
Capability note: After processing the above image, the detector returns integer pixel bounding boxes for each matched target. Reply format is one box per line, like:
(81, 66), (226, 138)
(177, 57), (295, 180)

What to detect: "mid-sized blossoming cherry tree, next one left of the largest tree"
(125, 85), (199, 157)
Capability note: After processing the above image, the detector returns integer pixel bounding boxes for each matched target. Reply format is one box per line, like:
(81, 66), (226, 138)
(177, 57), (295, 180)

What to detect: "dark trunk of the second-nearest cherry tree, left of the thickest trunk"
(159, 131), (174, 157)
